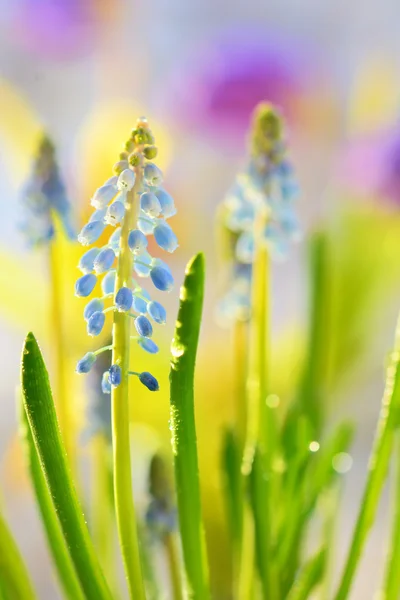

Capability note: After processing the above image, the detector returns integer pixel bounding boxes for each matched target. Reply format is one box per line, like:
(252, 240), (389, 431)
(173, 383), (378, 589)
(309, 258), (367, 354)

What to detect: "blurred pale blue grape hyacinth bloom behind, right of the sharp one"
(218, 103), (300, 321)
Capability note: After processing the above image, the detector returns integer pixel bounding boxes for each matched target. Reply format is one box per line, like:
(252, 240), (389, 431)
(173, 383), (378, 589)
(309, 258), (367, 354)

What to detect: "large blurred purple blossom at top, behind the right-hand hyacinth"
(169, 28), (315, 140)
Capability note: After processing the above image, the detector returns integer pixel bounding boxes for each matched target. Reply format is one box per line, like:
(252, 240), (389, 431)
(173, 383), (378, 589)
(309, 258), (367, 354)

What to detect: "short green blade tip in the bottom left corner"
(0, 513), (36, 600)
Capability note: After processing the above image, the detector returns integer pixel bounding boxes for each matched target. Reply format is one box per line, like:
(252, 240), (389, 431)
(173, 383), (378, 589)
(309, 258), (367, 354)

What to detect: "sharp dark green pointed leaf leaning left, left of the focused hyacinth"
(21, 333), (111, 600)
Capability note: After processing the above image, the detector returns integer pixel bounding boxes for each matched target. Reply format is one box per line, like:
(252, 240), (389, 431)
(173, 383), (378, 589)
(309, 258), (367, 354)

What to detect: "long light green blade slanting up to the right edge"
(335, 320), (400, 600)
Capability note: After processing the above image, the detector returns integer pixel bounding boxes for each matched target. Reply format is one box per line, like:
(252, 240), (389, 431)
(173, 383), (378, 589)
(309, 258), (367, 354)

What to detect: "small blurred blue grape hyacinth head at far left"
(20, 137), (76, 246)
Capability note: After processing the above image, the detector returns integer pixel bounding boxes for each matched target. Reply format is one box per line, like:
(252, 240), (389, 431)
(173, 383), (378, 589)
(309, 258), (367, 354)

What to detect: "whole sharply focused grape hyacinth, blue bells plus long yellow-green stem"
(75, 118), (177, 598)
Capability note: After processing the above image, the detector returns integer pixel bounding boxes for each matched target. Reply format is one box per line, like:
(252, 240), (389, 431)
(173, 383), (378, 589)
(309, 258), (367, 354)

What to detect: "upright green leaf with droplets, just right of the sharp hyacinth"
(170, 254), (210, 600)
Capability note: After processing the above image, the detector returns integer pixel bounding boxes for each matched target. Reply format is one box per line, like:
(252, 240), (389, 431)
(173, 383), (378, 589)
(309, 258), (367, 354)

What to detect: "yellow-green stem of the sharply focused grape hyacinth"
(111, 165), (145, 600)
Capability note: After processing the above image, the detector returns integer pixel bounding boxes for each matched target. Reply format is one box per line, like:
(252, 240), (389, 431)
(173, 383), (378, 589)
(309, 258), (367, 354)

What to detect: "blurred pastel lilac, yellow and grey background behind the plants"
(0, 0), (400, 600)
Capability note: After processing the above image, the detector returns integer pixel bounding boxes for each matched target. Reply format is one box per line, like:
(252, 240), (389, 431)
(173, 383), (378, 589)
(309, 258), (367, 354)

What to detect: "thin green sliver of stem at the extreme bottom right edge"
(382, 431), (400, 600)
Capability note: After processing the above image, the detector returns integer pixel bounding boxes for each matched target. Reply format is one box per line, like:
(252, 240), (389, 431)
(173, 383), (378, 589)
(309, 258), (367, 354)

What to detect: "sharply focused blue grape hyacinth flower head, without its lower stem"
(75, 118), (178, 397)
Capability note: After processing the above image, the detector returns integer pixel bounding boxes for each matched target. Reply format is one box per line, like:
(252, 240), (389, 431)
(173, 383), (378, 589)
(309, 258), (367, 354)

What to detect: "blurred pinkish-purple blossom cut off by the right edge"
(340, 123), (400, 206)
